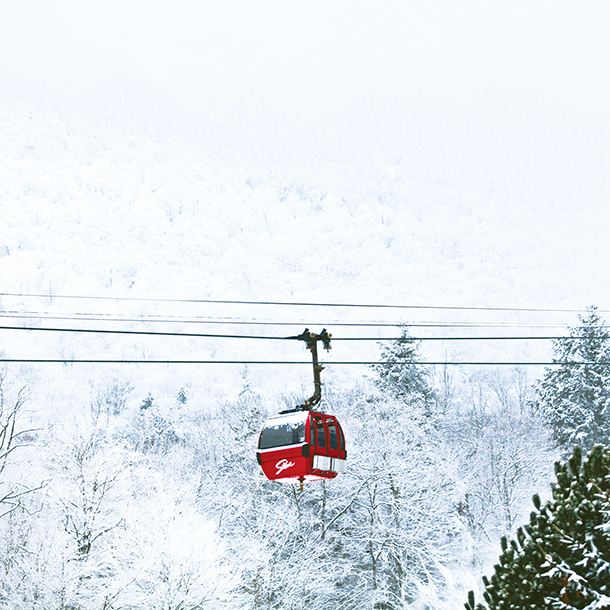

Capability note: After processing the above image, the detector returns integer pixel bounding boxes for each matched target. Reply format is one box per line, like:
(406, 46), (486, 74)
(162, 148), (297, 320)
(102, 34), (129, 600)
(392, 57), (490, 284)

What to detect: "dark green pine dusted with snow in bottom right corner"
(465, 445), (610, 610)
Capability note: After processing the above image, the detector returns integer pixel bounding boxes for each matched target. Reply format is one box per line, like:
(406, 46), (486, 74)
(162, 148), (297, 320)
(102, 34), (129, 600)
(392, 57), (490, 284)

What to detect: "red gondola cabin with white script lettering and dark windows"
(256, 411), (347, 484)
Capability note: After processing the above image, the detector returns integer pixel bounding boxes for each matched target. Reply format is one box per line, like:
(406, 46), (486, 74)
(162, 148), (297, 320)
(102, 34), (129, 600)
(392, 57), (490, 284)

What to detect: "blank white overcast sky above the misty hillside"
(0, 0), (610, 142)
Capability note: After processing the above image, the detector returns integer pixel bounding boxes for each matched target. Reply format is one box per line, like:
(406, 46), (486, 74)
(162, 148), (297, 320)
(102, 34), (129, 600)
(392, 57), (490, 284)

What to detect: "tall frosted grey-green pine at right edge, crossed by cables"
(534, 307), (610, 450)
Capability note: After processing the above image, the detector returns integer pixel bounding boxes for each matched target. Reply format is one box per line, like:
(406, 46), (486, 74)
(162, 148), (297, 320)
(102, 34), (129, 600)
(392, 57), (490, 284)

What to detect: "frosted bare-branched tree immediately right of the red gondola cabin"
(345, 384), (462, 610)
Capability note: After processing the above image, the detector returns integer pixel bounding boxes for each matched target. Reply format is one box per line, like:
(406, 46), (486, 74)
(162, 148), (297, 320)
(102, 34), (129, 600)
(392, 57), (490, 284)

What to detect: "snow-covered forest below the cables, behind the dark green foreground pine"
(0, 308), (610, 610)
